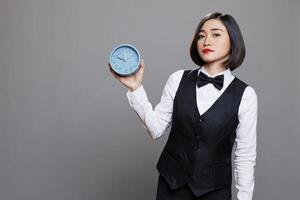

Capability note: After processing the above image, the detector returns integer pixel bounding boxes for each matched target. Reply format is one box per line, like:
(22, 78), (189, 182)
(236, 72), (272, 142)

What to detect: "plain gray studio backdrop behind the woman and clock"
(0, 0), (300, 200)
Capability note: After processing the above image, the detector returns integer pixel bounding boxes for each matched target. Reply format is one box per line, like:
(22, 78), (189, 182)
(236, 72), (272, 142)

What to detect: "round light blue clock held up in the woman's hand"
(109, 44), (141, 76)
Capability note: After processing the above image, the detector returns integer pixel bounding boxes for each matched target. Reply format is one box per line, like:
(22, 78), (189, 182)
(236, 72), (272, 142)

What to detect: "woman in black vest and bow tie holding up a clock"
(111, 13), (257, 200)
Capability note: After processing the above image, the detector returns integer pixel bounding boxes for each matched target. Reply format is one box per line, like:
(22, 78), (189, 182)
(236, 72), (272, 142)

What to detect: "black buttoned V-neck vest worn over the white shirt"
(156, 70), (247, 196)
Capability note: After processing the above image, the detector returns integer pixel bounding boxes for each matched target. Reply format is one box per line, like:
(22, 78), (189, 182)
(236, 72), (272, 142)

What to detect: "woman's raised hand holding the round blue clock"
(108, 59), (145, 91)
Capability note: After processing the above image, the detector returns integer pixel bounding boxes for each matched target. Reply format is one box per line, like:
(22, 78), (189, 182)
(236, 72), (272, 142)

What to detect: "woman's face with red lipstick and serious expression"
(197, 19), (230, 66)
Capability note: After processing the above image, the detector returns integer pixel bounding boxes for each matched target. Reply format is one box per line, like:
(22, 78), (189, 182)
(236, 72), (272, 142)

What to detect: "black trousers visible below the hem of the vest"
(156, 175), (231, 200)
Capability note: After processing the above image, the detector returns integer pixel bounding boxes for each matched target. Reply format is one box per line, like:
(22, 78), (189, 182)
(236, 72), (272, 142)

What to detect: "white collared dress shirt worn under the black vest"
(127, 67), (257, 200)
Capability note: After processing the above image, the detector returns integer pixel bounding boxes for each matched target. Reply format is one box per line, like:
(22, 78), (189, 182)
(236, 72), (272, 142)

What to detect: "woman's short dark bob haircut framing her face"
(190, 12), (246, 71)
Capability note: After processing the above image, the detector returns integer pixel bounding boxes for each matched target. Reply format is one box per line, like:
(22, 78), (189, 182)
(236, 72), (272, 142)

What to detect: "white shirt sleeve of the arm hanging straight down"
(234, 86), (257, 200)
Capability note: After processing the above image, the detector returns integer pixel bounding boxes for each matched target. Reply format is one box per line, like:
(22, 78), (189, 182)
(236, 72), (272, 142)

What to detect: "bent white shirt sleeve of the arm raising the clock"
(127, 70), (183, 140)
